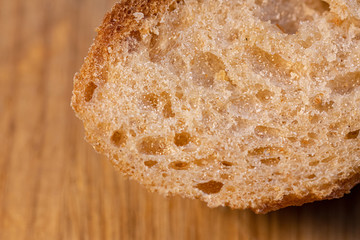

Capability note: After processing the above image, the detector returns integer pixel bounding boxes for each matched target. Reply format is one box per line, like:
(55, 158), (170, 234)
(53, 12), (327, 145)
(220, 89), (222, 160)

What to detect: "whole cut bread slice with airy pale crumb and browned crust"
(72, 0), (360, 213)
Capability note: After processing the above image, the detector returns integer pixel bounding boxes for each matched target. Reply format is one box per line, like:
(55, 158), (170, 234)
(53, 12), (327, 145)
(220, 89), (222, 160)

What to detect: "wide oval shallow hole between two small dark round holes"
(137, 136), (167, 155)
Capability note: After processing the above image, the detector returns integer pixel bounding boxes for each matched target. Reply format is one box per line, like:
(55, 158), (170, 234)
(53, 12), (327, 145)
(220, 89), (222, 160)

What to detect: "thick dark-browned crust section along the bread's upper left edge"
(71, 0), (174, 116)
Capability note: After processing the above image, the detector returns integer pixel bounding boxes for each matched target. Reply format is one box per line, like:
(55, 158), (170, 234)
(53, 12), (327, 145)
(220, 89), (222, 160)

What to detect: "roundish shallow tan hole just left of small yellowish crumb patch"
(191, 52), (225, 87)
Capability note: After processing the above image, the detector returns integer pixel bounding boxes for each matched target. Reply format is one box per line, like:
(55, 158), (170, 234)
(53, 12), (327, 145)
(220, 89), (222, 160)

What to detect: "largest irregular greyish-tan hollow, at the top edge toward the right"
(255, 0), (329, 34)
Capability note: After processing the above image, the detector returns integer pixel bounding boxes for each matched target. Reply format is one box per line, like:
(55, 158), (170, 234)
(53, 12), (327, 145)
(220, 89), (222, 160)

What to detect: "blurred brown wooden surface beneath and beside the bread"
(0, 0), (360, 240)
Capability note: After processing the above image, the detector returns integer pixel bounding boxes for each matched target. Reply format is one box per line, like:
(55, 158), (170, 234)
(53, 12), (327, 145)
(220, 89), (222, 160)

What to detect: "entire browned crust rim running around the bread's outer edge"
(71, 0), (360, 213)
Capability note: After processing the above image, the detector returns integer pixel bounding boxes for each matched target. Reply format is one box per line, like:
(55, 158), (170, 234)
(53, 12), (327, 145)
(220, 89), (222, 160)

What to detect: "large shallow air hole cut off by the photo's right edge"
(327, 72), (360, 95)
